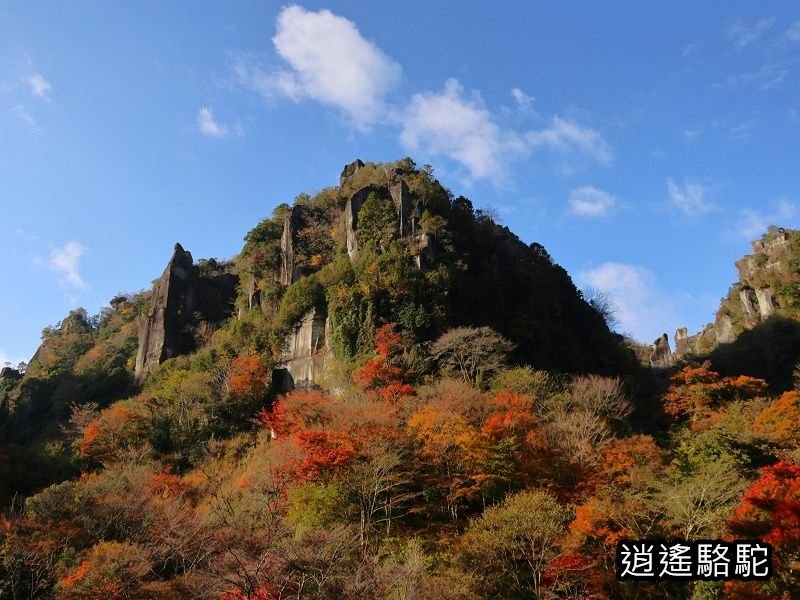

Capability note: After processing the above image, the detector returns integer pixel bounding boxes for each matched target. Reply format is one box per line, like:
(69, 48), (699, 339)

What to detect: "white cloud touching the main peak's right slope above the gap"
(577, 262), (679, 343)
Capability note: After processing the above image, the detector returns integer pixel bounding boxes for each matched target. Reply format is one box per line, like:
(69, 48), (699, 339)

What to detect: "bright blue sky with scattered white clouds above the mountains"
(0, 1), (800, 363)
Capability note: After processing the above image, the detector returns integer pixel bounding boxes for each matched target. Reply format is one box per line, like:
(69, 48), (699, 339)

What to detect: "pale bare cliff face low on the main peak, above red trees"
(272, 307), (331, 392)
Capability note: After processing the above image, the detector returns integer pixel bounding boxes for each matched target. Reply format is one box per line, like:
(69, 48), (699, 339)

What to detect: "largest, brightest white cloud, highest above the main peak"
(234, 6), (402, 129)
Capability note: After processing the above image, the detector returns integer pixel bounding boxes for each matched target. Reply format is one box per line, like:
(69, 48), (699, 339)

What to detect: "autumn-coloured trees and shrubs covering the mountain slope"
(0, 160), (800, 600)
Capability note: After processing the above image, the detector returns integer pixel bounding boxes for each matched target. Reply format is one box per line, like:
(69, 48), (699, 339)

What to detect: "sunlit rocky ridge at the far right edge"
(675, 228), (800, 357)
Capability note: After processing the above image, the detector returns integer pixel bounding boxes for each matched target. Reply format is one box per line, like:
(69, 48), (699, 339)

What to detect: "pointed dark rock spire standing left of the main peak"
(134, 244), (237, 382)
